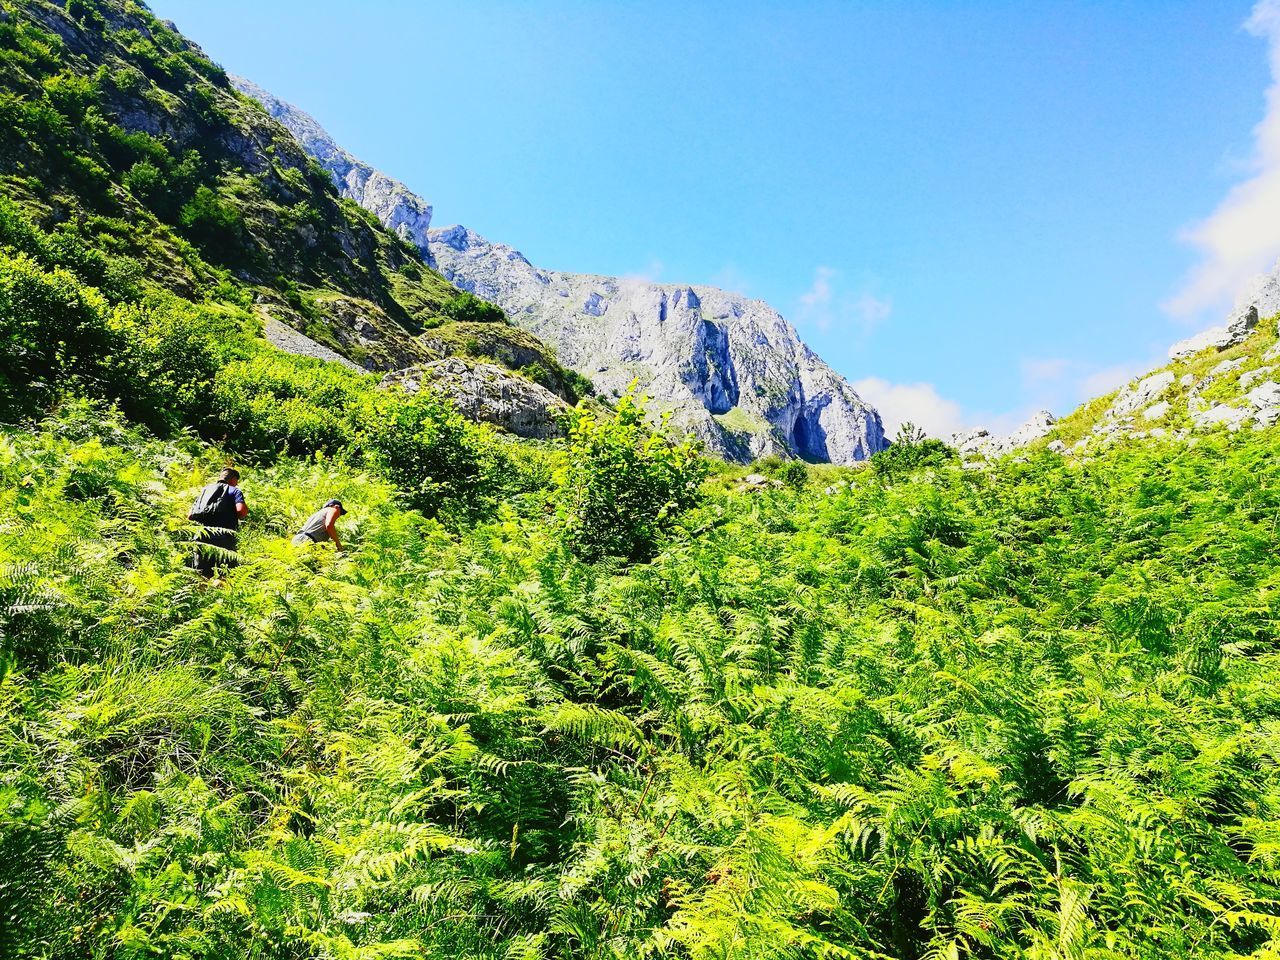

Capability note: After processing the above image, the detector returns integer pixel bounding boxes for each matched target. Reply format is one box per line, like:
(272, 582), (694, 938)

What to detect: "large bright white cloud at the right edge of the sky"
(1165, 0), (1280, 323)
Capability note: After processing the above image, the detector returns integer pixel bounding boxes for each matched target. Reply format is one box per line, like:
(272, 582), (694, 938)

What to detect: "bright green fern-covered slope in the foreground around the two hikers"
(0, 401), (1280, 960)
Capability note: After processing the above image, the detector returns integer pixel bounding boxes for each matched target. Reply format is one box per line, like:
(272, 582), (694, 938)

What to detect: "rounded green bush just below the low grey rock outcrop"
(364, 389), (498, 516)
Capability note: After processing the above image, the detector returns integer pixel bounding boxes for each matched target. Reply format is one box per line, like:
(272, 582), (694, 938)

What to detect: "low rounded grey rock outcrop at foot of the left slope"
(383, 357), (570, 439)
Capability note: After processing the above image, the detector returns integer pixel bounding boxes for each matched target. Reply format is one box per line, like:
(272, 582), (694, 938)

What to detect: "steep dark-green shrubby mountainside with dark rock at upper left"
(0, 0), (576, 389)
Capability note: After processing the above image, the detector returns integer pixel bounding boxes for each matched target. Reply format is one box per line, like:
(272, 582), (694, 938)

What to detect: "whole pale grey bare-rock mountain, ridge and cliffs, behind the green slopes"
(236, 81), (887, 463)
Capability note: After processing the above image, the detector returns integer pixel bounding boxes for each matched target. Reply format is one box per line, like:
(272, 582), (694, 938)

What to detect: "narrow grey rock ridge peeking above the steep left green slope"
(229, 77), (431, 248)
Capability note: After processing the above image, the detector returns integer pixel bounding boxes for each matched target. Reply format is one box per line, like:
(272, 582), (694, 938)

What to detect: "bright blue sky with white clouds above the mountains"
(152, 0), (1280, 433)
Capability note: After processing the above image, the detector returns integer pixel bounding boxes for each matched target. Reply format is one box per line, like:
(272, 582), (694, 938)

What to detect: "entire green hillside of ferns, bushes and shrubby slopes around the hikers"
(0, 0), (1280, 960)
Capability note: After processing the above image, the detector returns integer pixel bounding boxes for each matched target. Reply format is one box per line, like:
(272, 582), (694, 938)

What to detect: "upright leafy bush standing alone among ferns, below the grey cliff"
(557, 388), (707, 561)
